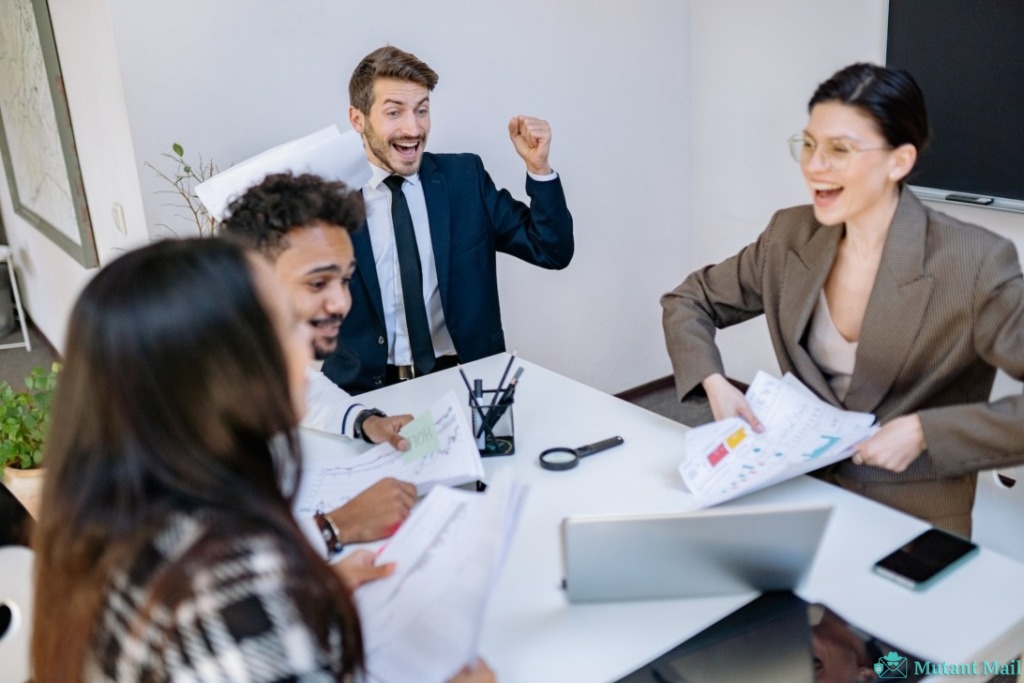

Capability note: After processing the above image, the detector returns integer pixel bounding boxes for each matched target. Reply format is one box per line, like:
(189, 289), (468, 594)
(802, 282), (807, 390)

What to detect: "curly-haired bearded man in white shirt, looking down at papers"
(219, 173), (416, 552)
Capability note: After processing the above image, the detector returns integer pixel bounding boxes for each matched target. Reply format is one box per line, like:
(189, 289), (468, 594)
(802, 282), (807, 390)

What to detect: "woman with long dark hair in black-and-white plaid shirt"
(32, 240), (489, 683)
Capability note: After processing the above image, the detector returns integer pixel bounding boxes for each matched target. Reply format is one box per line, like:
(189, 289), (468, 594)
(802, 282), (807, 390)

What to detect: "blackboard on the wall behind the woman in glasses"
(886, 0), (1024, 211)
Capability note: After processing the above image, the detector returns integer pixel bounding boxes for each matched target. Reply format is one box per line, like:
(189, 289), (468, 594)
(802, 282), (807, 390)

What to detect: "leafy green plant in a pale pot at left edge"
(0, 362), (60, 516)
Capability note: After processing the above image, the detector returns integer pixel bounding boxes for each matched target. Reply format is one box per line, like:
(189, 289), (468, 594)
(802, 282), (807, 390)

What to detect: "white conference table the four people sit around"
(350, 354), (1024, 683)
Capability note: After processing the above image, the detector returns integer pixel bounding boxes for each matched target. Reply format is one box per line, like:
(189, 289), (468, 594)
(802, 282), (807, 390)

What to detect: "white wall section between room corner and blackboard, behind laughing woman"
(692, 0), (885, 382)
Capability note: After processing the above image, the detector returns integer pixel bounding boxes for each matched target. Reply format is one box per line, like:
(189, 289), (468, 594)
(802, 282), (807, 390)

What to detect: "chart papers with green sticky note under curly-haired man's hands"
(292, 391), (483, 545)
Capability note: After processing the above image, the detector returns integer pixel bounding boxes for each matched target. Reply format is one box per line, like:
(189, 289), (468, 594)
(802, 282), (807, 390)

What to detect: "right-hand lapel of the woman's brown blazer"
(845, 188), (933, 413)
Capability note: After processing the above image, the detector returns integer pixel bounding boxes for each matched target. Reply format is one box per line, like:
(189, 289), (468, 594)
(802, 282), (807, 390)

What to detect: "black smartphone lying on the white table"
(874, 528), (978, 591)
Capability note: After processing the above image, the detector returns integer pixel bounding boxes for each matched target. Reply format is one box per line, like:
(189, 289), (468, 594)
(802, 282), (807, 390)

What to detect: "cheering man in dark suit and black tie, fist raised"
(324, 46), (573, 393)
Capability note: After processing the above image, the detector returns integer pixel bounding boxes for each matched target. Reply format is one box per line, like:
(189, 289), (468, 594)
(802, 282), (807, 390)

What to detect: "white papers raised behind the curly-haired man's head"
(196, 124), (371, 221)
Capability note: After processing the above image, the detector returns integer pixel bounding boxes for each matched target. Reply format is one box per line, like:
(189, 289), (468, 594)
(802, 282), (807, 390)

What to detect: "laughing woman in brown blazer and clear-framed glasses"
(662, 63), (1024, 536)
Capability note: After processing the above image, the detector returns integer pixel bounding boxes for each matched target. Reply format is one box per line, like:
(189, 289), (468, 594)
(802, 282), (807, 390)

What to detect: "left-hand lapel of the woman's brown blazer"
(778, 225), (843, 405)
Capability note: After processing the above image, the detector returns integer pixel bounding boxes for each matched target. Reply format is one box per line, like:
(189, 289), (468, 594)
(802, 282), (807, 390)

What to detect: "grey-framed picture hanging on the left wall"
(0, 0), (99, 267)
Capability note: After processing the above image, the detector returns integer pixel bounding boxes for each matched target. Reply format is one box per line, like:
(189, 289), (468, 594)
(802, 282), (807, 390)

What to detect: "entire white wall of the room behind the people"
(8, 0), (1024, 391)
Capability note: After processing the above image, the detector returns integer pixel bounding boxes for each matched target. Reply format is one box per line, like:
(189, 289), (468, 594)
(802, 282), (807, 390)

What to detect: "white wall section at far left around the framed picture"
(0, 0), (147, 352)
